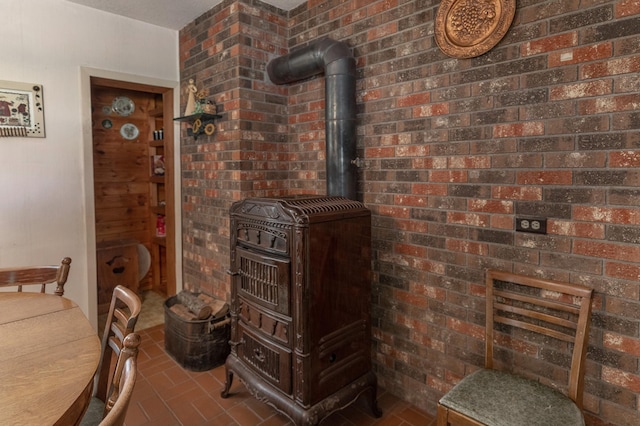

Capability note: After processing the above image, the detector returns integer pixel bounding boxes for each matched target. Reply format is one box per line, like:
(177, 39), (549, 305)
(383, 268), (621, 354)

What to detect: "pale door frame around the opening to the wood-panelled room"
(80, 67), (183, 329)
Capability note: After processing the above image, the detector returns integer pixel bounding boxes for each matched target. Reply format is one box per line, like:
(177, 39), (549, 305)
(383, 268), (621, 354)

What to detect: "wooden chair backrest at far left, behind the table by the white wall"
(0, 257), (71, 296)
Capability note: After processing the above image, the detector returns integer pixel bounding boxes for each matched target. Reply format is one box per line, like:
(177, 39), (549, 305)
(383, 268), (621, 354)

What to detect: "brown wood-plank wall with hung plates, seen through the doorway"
(92, 86), (161, 294)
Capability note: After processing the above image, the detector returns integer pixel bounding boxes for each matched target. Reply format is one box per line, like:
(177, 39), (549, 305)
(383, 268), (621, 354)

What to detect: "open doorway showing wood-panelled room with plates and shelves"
(90, 77), (176, 314)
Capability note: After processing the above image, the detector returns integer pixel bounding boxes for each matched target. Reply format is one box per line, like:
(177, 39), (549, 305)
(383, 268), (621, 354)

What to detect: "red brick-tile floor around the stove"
(125, 325), (435, 426)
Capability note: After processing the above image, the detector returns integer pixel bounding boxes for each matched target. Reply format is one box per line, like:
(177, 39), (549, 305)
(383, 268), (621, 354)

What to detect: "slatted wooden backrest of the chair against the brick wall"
(485, 270), (593, 408)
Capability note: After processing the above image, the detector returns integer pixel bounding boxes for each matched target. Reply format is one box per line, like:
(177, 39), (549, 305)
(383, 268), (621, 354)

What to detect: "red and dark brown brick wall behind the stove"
(181, 0), (640, 425)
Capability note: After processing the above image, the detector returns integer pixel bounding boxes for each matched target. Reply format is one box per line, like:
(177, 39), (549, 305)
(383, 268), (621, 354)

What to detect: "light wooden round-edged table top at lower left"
(0, 292), (100, 426)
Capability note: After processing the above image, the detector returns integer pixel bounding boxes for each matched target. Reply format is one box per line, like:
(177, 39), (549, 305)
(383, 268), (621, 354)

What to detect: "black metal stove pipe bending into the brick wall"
(267, 38), (358, 200)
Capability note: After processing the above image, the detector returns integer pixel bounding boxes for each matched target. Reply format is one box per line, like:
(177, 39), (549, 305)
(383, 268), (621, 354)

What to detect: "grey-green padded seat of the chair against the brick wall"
(440, 370), (584, 426)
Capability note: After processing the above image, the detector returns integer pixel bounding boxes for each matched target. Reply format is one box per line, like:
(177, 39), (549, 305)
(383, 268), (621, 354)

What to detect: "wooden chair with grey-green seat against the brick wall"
(437, 270), (593, 426)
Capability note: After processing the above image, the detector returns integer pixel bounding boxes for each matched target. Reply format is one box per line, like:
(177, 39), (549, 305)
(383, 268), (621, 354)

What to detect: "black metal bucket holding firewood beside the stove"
(164, 296), (231, 371)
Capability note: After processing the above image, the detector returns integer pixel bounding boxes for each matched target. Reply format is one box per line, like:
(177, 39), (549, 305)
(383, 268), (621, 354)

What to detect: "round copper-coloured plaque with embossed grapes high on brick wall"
(435, 0), (516, 58)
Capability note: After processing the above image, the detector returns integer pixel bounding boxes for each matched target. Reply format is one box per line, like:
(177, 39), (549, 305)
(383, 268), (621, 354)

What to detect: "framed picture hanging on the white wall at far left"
(0, 80), (45, 138)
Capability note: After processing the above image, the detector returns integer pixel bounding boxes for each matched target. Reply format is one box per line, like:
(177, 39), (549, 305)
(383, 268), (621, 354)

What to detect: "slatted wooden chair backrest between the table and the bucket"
(94, 285), (142, 403)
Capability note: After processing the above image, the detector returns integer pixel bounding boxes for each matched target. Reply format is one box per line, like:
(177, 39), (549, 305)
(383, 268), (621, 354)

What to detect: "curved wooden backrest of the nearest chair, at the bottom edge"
(100, 333), (140, 426)
